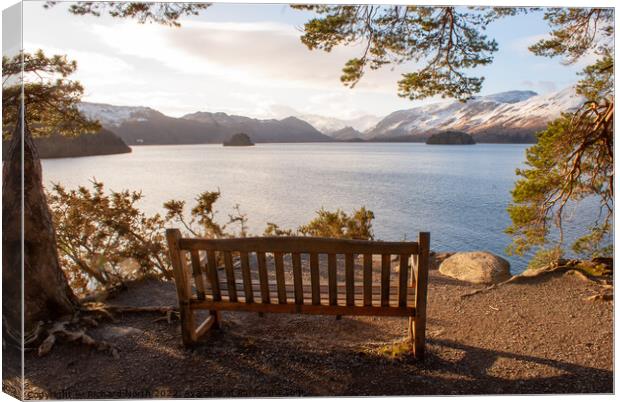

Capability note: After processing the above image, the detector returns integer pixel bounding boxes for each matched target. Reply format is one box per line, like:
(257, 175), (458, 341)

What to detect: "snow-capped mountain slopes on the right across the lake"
(364, 87), (583, 142)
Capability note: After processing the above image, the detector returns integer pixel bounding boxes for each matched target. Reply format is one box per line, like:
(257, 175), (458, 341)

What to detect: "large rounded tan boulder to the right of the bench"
(439, 251), (511, 284)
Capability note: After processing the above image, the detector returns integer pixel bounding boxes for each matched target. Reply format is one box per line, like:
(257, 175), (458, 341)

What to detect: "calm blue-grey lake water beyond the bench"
(43, 143), (592, 273)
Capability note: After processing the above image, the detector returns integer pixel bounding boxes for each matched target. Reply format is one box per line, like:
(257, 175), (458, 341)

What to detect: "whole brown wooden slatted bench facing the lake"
(166, 229), (430, 359)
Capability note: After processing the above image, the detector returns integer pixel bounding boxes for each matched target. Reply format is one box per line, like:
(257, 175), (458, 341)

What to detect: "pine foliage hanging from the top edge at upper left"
(43, 1), (211, 27)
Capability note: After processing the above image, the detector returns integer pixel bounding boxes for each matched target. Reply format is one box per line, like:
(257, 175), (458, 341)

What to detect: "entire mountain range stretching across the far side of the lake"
(79, 87), (583, 145)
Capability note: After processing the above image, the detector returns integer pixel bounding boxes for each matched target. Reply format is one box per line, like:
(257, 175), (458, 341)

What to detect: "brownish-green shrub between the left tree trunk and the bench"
(48, 180), (172, 294)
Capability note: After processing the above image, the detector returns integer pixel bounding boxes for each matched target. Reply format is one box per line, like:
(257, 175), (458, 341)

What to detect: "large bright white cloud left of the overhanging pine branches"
(91, 21), (399, 92)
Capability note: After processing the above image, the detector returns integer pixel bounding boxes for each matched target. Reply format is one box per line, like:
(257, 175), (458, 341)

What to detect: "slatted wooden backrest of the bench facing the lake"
(166, 229), (430, 310)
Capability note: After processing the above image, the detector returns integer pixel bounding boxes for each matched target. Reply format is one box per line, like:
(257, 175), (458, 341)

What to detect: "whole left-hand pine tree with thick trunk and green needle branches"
(2, 2), (208, 344)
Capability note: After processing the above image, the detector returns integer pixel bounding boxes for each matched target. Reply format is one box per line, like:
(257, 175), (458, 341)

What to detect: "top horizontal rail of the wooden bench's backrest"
(180, 236), (418, 254)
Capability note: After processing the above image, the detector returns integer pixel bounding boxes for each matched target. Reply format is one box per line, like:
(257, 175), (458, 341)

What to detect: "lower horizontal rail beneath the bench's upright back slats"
(190, 300), (415, 317)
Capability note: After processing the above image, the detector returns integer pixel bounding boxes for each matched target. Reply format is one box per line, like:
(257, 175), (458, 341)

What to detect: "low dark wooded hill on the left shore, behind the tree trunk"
(2, 129), (131, 160)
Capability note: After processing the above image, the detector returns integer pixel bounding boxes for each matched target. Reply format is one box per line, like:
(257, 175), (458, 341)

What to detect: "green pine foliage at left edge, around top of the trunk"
(2, 50), (100, 139)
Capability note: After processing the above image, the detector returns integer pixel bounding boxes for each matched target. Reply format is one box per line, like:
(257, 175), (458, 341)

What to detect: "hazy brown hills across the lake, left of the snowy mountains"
(80, 103), (332, 145)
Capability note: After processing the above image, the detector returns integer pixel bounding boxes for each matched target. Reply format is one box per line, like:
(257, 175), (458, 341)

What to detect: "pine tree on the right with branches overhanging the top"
(293, 5), (614, 260)
